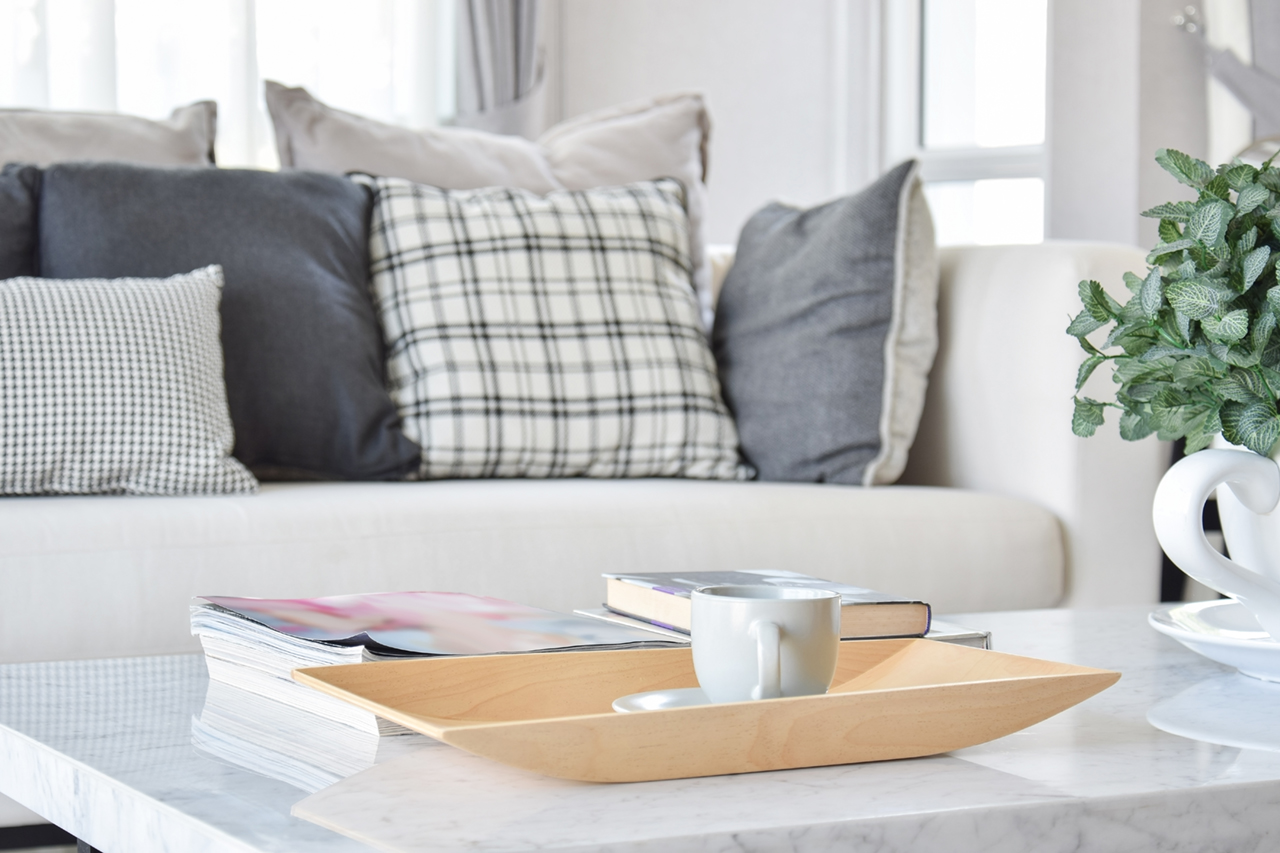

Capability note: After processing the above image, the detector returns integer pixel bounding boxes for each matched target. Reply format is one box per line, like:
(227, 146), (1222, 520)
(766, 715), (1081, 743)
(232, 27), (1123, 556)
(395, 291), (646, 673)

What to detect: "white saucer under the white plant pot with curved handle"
(1147, 598), (1280, 681)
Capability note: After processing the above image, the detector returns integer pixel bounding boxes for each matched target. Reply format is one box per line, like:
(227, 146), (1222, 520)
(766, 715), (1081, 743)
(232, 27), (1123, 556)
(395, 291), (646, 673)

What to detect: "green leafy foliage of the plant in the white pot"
(1066, 149), (1280, 456)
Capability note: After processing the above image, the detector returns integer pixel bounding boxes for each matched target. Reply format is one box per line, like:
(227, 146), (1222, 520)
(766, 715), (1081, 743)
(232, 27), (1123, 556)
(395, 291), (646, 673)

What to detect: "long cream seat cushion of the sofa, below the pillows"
(0, 479), (1064, 662)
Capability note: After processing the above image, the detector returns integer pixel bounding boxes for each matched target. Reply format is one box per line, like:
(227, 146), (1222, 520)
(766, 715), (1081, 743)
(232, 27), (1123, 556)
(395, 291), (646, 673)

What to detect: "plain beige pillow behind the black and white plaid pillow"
(266, 81), (710, 316)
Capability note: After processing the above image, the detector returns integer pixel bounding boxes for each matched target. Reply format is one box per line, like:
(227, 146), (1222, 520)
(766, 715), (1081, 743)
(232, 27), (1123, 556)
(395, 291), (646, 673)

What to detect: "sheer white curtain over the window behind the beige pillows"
(0, 0), (454, 168)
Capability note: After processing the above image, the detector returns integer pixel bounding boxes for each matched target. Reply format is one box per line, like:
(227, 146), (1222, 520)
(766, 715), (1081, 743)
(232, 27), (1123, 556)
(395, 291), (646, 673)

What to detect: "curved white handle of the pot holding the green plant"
(1151, 450), (1280, 638)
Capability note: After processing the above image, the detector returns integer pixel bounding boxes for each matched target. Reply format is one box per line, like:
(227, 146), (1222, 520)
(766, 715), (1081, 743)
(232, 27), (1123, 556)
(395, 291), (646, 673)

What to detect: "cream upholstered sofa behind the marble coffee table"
(0, 243), (1169, 826)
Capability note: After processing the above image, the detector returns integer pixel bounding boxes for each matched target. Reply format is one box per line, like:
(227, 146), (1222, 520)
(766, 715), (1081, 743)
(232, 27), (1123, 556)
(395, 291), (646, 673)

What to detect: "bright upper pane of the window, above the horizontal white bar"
(922, 0), (1047, 149)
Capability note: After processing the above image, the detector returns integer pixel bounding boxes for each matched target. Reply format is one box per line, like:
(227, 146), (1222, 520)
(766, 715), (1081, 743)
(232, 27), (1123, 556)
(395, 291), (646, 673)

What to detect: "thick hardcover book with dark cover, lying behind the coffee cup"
(604, 570), (932, 639)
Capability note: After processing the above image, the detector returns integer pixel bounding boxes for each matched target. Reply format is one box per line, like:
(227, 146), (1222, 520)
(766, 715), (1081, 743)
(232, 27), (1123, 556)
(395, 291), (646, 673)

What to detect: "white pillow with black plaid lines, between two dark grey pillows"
(360, 177), (751, 479)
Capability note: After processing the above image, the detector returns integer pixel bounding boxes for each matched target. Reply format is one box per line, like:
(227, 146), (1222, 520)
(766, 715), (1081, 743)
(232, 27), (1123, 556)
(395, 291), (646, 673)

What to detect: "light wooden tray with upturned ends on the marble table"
(293, 639), (1120, 783)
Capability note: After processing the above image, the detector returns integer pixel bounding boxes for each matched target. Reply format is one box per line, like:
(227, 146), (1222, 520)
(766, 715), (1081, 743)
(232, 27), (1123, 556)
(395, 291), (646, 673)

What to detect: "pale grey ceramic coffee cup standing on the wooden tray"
(690, 585), (840, 702)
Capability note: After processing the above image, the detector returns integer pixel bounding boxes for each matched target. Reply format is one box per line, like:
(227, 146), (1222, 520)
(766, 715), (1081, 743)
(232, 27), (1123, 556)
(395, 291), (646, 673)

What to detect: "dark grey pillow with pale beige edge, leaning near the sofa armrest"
(713, 161), (938, 485)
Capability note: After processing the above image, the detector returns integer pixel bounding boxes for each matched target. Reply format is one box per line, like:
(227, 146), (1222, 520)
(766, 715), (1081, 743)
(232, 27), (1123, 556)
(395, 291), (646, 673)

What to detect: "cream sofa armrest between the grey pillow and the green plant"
(901, 242), (1170, 606)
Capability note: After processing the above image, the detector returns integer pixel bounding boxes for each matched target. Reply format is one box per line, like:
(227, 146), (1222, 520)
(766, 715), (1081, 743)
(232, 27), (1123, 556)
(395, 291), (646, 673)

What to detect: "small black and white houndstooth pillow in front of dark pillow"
(0, 266), (257, 494)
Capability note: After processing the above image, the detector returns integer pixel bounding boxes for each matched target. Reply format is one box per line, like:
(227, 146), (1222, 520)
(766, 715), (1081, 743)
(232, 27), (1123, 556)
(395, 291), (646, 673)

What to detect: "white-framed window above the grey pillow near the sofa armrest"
(883, 0), (1048, 245)
